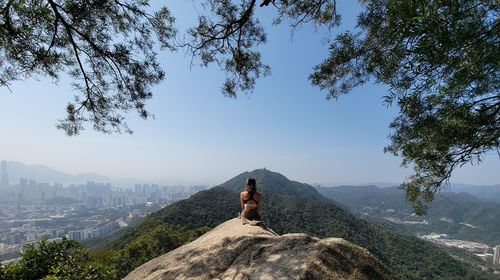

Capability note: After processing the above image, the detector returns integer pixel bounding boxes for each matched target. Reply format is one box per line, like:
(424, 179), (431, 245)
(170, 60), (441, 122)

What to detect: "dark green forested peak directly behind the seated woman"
(103, 169), (494, 279)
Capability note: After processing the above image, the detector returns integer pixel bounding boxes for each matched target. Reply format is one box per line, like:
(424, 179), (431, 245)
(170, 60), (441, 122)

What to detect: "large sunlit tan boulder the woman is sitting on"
(124, 219), (394, 280)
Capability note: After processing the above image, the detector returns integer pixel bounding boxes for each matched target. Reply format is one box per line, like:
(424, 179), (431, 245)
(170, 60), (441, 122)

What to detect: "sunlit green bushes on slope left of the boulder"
(0, 222), (210, 280)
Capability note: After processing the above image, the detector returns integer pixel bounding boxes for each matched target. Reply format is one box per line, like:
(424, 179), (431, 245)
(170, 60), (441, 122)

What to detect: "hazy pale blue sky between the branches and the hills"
(0, 1), (500, 184)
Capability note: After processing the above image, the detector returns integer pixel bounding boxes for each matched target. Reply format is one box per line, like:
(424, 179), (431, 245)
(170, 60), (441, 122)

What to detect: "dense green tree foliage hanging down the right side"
(311, 0), (500, 214)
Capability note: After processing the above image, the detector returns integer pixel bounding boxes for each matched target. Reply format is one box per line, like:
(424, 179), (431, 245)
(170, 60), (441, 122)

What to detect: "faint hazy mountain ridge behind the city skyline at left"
(0, 161), (110, 185)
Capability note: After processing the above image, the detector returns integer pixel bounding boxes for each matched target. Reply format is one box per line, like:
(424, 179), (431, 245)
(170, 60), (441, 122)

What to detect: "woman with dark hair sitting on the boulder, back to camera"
(240, 177), (262, 224)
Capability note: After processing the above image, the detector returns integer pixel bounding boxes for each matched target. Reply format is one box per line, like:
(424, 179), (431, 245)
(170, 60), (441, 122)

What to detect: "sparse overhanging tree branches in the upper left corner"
(0, 0), (175, 135)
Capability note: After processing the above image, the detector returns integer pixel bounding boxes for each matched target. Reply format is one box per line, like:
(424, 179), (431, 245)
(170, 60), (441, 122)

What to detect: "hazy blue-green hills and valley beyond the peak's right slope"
(317, 186), (500, 245)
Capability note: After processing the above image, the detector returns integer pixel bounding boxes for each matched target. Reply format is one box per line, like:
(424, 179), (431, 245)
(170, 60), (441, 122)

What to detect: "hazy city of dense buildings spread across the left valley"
(0, 161), (205, 261)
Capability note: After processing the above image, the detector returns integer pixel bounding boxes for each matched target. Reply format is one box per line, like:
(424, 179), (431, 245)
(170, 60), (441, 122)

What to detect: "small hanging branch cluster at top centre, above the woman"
(185, 0), (340, 97)
